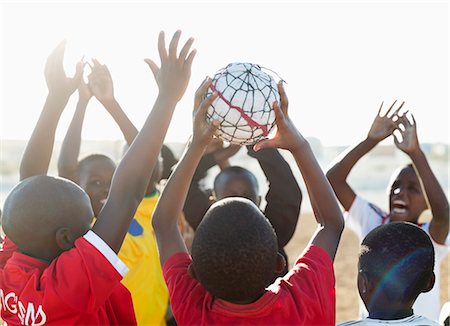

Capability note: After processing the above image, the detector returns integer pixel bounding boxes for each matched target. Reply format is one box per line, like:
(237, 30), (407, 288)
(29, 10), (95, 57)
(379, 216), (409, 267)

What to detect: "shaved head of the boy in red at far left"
(2, 176), (94, 262)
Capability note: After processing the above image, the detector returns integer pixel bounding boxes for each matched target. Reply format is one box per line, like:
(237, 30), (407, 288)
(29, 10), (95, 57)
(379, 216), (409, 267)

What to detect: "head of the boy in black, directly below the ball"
(214, 166), (261, 206)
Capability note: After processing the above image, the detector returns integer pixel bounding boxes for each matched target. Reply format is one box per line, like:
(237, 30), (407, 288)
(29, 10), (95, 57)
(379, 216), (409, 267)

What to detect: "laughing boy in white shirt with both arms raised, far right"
(327, 102), (449, 320)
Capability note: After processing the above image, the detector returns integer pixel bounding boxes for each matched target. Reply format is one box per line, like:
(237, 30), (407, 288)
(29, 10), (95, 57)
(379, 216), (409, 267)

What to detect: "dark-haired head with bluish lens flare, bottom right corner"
(358, 222), (434, 314)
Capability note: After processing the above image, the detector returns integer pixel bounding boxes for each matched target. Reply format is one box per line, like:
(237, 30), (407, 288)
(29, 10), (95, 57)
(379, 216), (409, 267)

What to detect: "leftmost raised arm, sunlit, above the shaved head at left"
(20, 41), (83, 180)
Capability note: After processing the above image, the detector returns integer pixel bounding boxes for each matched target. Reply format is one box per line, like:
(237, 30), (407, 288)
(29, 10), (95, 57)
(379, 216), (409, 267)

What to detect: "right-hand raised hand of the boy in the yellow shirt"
(88, 59), (114, 104)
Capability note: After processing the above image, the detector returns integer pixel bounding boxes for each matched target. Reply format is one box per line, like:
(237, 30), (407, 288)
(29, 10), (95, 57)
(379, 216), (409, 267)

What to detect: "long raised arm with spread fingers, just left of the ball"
(92, 31), (195, 252)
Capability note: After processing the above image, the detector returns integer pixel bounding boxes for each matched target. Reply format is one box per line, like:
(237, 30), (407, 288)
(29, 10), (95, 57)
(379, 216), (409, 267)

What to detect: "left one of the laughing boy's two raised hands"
(367, 100), (405, 142)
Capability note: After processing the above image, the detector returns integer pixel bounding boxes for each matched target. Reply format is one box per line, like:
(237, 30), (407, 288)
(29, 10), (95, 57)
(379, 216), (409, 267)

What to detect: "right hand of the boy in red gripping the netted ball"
(253, 81), (305, 152)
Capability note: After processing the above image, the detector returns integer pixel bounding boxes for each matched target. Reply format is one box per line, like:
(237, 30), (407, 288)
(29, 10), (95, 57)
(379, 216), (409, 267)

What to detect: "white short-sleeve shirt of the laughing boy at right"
(344, 196), (450, 320)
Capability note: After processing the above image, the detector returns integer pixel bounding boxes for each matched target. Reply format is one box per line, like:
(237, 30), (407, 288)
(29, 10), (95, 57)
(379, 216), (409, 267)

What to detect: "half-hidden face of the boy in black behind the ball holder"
(214, 177), (260, 206)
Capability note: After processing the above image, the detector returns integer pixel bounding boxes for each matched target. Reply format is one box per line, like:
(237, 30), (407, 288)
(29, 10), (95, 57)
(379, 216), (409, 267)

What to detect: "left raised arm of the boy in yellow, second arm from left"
(58, 79), (92, 183)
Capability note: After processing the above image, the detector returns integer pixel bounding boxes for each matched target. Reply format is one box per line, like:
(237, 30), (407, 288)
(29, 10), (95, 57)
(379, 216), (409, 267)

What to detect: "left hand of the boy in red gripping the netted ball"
(192, 78), (219, 146)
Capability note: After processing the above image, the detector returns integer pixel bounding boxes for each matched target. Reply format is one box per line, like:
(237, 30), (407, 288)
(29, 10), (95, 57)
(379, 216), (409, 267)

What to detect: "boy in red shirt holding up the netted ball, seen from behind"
(153, 79), (344, 325)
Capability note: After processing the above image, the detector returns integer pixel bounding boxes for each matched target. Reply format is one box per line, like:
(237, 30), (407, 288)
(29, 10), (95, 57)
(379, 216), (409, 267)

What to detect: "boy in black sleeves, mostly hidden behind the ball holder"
(183, 135), (302, 276)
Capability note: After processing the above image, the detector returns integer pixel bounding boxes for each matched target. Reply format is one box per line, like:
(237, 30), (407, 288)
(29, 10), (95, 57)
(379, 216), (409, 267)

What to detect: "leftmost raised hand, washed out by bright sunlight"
(44, 40), (84, 100)
